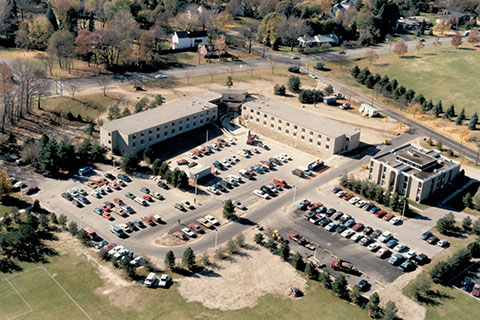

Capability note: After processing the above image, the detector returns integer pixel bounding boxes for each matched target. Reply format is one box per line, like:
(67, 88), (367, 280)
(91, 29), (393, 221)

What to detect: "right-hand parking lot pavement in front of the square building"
(269, 185), (443, 292)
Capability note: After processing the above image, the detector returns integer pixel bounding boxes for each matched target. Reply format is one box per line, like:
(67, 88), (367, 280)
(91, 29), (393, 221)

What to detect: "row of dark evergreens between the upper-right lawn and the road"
(350, 65), (478, 130)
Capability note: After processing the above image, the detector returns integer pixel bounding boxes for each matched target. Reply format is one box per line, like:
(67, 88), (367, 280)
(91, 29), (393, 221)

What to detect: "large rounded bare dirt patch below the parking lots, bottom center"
(178, 230), (306, 310)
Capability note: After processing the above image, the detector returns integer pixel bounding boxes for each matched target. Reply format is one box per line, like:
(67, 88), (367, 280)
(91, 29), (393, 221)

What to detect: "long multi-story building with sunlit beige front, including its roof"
(242, 98), (360, 154)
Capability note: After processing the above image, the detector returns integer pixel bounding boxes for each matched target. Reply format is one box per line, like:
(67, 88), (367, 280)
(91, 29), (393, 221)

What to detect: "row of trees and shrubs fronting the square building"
(340, 174), (415, 217)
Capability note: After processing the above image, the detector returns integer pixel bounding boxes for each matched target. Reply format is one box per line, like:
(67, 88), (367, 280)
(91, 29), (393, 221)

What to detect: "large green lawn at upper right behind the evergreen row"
(327, 45), (480, 117)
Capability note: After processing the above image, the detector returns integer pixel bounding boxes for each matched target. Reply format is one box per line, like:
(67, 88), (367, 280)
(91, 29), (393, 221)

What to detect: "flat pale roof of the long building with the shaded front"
(102, 92), (222, 134)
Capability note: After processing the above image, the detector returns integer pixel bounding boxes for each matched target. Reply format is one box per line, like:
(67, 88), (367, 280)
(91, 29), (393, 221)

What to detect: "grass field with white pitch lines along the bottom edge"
(0, 232), (370, 320)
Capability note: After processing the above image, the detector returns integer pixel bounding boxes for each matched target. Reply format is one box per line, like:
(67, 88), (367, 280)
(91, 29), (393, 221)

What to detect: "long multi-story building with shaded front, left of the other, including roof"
(100, 92), (222, 155)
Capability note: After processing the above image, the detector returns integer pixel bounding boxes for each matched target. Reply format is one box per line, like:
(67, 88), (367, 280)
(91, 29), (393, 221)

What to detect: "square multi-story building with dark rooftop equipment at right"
(368, 143), (460, 202)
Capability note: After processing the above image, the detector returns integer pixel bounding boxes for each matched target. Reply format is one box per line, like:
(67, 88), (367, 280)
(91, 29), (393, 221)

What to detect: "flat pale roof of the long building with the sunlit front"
(244, 98), (360, 137)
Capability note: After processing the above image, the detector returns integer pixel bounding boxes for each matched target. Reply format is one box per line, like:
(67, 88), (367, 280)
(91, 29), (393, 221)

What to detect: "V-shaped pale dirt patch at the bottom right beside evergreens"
(378, 268), (427, 320)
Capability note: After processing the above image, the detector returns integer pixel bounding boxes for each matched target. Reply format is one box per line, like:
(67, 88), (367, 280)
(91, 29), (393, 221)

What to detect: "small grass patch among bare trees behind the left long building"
(41, 92), (122, 120)
